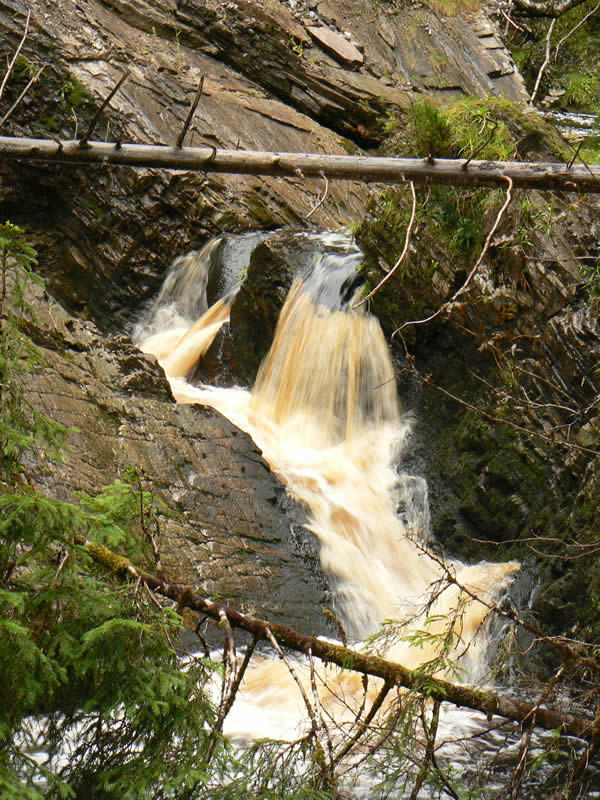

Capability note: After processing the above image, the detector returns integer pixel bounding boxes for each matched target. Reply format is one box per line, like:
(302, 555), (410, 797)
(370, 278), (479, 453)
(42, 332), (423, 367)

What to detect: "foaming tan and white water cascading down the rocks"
(138, 236), (518, 738)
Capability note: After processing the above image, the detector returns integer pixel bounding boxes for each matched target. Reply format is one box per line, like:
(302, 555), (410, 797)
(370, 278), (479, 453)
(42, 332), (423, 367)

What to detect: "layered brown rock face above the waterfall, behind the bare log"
(0, 0), (524, 331)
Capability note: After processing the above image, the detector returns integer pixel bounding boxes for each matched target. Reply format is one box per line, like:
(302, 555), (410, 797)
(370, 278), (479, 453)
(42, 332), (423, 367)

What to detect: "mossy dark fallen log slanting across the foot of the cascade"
(85, 541), (598, 740)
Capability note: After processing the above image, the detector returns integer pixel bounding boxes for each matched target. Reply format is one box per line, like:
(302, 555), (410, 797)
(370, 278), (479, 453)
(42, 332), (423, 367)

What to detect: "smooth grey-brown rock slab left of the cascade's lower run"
(21, 282), (327, 633)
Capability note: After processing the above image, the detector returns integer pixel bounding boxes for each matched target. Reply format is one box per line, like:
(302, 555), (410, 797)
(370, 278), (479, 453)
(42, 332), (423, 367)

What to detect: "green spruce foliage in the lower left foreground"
(0, 223), (220, 800)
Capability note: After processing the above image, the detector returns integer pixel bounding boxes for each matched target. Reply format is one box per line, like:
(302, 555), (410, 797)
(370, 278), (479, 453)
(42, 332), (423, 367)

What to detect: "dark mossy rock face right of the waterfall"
(358, 100), (600, 641)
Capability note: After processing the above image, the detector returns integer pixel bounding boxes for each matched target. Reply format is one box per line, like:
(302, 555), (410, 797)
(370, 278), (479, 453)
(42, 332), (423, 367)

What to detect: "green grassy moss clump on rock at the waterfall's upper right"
(357, 97), (569, 312)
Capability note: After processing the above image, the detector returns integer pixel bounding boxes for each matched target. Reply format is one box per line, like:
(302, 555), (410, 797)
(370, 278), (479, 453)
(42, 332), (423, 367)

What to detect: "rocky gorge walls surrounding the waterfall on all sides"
(0, 0), (600, 652)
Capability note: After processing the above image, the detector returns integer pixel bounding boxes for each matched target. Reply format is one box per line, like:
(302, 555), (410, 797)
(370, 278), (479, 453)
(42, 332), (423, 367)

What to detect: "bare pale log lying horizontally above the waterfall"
(0, 136), (600, 193)
